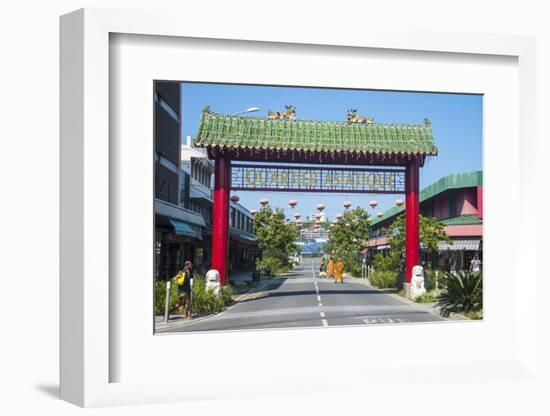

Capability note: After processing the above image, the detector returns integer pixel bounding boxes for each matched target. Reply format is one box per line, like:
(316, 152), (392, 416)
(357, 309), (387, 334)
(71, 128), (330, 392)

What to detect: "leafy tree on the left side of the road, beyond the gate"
(253, 206), (298, 273)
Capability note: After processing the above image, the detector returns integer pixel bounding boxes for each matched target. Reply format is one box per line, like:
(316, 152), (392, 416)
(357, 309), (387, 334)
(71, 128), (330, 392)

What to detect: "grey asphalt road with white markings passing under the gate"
(169, 259), (444, 332)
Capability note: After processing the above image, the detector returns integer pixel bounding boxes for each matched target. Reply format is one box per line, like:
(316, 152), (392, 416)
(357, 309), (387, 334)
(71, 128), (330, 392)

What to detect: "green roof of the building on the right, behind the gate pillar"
(370, 171), (483, 227)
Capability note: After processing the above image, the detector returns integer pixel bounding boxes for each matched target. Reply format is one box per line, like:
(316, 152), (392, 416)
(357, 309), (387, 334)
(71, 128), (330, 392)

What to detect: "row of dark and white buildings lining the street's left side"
(154, 89), (259, 280)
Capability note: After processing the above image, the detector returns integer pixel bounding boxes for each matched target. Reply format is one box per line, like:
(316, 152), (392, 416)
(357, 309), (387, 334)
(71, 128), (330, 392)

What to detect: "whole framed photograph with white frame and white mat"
(61, 9), (538, 412)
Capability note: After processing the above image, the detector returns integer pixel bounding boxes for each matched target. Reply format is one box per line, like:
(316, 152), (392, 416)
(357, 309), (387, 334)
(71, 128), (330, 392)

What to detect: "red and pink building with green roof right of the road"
(366, 171), (483, 270)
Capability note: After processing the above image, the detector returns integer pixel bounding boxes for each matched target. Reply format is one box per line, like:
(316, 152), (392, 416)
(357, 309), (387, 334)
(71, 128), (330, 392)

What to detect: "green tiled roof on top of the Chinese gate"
(195, 111), (437, 156)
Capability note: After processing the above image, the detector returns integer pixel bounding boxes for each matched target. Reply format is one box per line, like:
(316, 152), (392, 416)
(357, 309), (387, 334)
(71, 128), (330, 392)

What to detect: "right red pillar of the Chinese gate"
(404, 158), (420, 298)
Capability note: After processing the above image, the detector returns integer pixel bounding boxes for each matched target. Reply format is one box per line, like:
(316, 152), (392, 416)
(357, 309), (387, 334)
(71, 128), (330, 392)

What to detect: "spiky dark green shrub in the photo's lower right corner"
(437, 271), (483, 316)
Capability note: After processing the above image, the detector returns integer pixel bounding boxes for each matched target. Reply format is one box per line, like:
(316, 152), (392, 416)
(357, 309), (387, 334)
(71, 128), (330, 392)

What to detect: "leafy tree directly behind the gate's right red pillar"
(385, 215), (451, 269)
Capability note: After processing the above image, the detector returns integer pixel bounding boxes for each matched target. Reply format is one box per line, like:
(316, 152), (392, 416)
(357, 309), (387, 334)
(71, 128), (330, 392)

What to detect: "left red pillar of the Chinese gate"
(212, 157), (231, 285)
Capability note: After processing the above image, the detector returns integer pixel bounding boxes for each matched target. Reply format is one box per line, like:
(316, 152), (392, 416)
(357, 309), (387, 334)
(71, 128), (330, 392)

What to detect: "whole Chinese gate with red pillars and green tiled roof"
(195, 107), (437, 293)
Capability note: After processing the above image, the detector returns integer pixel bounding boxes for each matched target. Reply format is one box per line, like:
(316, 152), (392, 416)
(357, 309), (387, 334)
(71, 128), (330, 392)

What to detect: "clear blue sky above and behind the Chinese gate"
(182, 83), (483, 223)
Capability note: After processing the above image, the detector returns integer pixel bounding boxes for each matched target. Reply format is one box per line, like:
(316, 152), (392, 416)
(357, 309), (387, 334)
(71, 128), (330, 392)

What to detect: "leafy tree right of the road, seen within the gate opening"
(325, 207), (370, 276)
